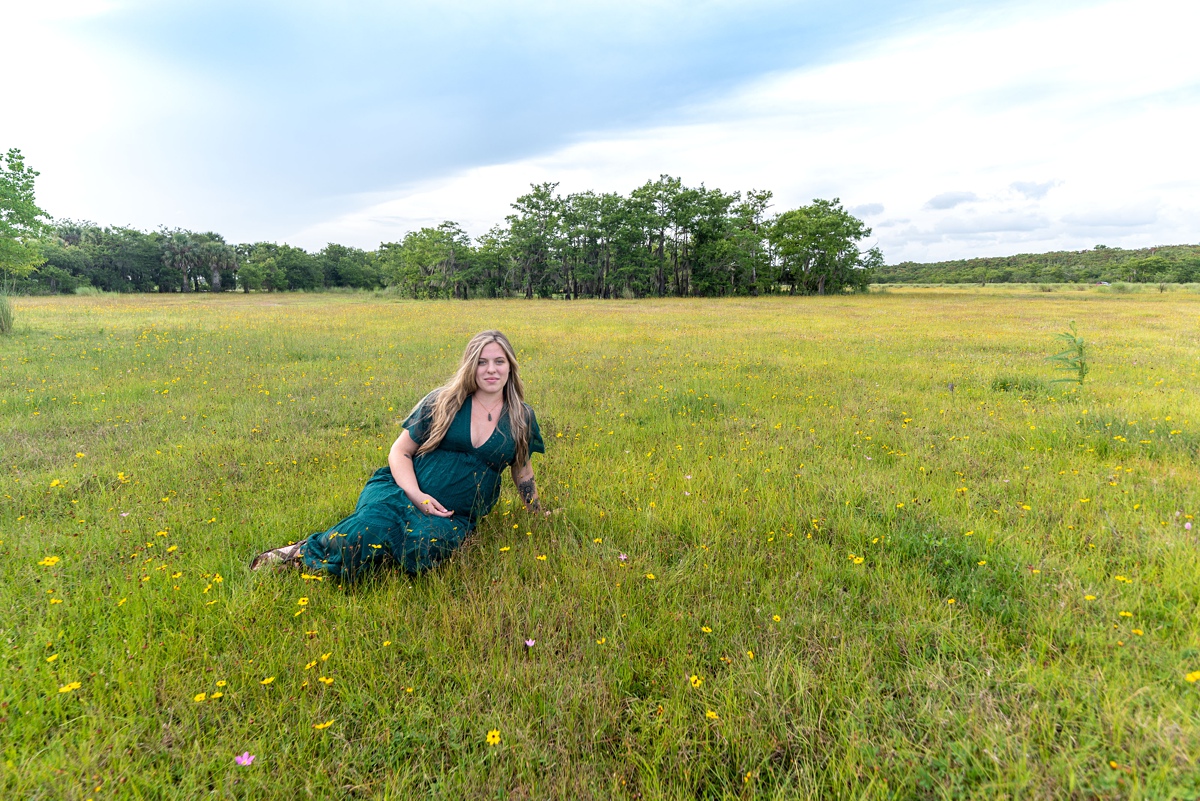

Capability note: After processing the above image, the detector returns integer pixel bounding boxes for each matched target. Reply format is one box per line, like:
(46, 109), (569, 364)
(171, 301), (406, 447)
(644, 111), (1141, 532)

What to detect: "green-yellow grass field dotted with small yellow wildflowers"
(0, 288), (1200, 800)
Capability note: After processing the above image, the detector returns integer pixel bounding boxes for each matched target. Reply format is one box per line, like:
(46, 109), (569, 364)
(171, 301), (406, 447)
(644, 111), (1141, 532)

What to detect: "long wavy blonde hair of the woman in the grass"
(416, 331), (529, 466)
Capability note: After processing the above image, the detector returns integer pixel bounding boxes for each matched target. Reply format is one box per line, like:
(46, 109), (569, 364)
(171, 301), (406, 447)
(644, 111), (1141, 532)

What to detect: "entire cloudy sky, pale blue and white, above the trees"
(0, 0), (1200, 263)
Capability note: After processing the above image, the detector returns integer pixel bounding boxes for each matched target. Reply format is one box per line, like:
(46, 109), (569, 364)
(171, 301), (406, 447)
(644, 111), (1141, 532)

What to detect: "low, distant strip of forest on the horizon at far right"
(871, 245), (1200, 284)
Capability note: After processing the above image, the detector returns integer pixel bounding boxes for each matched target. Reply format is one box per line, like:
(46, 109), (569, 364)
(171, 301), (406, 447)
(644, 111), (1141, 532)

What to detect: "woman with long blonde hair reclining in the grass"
(250, 331), (548, 580)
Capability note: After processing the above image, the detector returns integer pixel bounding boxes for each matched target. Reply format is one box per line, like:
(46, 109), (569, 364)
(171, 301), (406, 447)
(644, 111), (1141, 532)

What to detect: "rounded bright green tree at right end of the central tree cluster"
(768, 198), (874, 295)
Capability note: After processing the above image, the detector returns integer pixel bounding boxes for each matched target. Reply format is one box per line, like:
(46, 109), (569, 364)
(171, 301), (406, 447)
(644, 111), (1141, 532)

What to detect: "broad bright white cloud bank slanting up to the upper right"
(294, 0), (1200, 261)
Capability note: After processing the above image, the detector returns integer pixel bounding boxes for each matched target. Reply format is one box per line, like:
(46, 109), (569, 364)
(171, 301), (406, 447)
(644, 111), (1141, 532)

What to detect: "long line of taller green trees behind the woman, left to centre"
(13, 175), (883, 299)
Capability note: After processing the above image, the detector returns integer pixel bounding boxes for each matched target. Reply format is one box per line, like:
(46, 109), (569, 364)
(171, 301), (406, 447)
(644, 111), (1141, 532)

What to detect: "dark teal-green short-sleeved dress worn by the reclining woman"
(301, 393), (546, 580)
